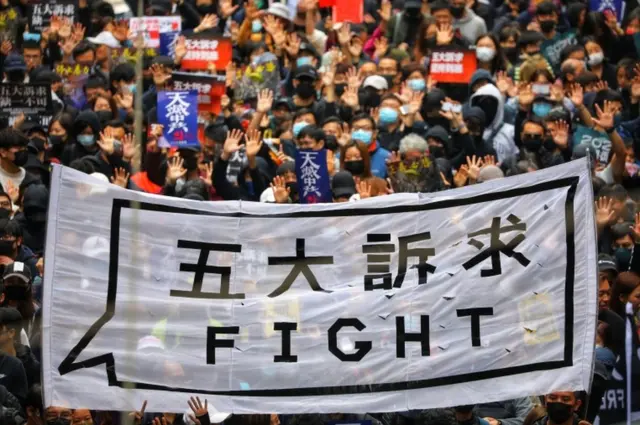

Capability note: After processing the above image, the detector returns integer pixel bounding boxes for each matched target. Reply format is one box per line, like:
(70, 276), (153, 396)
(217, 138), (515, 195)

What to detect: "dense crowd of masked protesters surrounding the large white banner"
(0, 0), (640, 425)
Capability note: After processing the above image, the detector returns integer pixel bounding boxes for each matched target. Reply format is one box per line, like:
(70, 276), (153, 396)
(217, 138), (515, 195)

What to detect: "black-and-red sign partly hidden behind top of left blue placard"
(171, 72), (226, 114)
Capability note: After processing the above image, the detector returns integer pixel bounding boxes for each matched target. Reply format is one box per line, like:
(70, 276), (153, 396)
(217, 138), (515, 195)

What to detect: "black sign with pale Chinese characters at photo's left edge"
(0, 83), (53, 125)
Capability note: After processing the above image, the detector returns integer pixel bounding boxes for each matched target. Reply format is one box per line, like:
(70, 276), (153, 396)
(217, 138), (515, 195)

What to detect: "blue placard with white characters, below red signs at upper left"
(158, 91), (199, 147)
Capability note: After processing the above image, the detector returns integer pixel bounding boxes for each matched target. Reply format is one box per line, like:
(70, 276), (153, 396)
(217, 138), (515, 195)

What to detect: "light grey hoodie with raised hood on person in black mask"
(470, 84), (520, 163)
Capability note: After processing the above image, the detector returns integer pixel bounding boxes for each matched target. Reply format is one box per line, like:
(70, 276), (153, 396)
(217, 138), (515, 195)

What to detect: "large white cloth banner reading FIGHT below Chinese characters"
(43, 161), (597, 413)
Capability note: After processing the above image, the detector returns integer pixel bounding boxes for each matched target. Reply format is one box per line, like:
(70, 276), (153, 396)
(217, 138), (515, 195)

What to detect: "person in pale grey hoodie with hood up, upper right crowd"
(470, 83), (519, 163)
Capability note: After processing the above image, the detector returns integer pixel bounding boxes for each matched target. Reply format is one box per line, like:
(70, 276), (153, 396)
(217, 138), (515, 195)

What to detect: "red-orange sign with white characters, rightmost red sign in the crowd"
(429, 50), (477, 84)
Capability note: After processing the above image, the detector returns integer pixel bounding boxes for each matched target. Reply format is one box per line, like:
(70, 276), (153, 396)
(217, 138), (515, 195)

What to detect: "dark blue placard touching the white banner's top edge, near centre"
(296, 149), (333, 204)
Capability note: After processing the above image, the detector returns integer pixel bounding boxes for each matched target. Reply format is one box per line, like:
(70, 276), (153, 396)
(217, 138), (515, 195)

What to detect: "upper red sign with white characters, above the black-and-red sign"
(182, 33), (232, 71)
